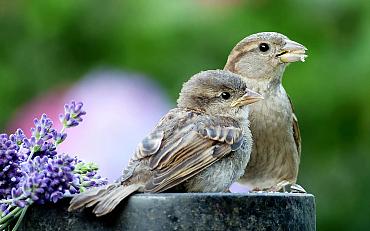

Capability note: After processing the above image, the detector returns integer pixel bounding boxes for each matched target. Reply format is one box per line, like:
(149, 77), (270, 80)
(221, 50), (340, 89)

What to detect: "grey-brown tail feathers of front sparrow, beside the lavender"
(68, 183), (140, 217)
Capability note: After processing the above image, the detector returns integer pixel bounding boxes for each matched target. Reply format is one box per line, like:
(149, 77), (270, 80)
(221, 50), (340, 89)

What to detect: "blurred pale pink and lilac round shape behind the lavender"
(9, 70), (171, 181)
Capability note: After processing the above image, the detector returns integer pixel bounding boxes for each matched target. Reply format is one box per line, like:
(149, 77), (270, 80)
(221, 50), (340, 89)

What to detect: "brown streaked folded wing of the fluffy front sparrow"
(145, 114), (243, 192)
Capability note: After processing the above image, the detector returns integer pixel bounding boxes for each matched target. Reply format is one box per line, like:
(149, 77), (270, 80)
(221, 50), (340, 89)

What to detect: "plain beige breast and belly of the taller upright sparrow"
(242, 90), (298, 188)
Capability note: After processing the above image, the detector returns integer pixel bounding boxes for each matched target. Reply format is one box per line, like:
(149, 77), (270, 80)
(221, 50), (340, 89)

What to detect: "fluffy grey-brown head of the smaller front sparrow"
(177, 70), (263, 117)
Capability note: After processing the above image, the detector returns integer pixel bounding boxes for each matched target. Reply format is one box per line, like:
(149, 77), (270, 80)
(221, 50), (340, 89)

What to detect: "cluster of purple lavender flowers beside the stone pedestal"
(0, 101), (107, 230)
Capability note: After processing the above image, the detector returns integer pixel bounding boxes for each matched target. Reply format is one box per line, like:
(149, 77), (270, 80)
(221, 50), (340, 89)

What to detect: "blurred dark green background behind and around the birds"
(0, 0), (370, 230)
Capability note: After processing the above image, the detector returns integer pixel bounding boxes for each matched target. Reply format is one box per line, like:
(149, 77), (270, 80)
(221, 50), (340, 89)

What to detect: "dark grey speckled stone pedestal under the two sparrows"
(20, 193), (316, 231)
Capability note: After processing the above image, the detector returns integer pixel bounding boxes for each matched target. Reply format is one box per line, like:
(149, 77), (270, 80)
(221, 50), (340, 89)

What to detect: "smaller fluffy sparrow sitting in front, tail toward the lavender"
(68, 70), (262, 216)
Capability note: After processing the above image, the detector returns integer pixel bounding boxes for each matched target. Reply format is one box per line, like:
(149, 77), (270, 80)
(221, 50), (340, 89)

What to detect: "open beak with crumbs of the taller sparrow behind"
(276, 39), (307, 63)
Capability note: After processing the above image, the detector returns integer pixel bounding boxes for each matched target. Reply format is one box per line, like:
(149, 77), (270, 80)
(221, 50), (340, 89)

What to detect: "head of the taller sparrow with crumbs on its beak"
(224, 32), (307, 81)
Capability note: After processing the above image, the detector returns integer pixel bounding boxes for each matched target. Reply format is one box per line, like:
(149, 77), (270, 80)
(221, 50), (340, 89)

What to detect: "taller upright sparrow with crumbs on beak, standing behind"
(224, 32), (307, 192)
